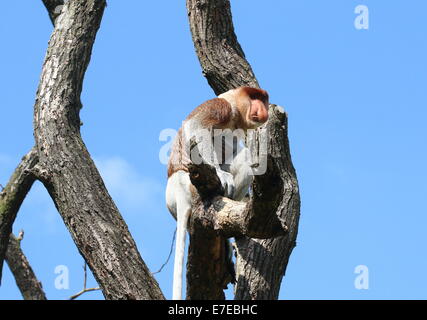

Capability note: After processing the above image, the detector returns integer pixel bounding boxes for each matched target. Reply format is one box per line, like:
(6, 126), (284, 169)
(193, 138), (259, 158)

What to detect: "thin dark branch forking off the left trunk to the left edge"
(0, 148), (38, 281)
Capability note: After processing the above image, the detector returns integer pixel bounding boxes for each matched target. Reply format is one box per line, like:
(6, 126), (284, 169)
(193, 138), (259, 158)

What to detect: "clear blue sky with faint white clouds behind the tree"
(0, 0), (427, 299)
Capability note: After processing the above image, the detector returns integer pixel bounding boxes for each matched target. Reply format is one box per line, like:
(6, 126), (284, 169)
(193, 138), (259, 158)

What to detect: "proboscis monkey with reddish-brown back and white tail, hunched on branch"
(166, 87), (269, 300)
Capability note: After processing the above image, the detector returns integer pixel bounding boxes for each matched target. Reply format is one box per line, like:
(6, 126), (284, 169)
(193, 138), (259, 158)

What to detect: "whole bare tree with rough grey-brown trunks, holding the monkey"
(0, 0), (300, 300)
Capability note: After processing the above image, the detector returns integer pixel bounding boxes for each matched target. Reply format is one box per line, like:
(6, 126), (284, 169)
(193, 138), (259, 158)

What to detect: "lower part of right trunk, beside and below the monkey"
(235, 108), (300, 300)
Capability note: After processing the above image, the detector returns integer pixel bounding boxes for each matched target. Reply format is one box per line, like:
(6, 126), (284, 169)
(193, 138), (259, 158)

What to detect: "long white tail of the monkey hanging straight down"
(172, 203), (191, 300)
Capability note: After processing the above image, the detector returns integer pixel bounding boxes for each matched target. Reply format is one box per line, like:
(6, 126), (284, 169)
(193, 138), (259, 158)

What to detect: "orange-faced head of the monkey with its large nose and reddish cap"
(237, 87), (269, 129)
